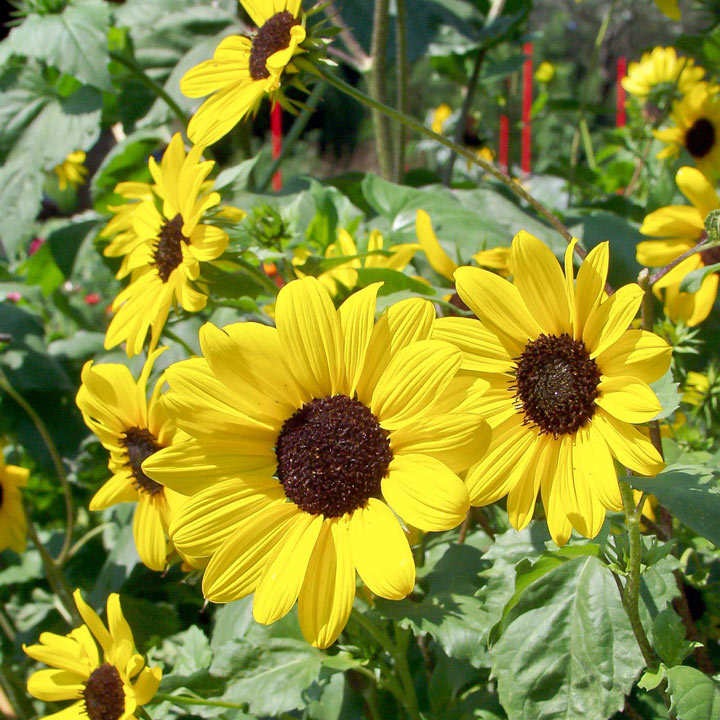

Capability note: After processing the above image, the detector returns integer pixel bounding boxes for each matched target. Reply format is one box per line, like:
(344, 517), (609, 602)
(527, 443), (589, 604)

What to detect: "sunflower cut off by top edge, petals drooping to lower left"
(180, 0), (305, 146)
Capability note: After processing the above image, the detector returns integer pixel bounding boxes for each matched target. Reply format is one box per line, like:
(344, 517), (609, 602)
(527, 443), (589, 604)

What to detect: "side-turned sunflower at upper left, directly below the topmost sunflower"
(104, 133), (242, 356)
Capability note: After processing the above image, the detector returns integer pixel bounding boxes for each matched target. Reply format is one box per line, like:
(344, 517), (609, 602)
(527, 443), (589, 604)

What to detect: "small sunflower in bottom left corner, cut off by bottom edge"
(23, 590), (162, 720)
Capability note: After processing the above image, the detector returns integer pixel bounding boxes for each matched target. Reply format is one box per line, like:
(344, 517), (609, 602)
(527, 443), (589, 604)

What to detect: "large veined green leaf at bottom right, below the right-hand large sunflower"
(492, 557), (643, 720)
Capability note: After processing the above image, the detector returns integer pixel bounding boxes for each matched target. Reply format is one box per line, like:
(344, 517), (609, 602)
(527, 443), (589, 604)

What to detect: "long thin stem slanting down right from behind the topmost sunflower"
(294, 58), (586, 248)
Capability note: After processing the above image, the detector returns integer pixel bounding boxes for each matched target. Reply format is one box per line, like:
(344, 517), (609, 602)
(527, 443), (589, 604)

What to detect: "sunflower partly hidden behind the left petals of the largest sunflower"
(76, 348), (186, 570)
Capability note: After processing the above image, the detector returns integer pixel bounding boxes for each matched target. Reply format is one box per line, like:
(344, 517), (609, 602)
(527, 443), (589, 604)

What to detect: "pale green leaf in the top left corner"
(7, 0), (112, 90)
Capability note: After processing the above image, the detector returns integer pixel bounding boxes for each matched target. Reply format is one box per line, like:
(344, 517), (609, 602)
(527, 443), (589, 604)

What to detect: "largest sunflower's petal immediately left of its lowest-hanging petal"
(253, 512), (325, 625)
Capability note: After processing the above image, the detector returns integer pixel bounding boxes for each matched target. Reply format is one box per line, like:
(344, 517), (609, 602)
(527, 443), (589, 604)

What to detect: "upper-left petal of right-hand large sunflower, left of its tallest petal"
(455, 267), (543, 357)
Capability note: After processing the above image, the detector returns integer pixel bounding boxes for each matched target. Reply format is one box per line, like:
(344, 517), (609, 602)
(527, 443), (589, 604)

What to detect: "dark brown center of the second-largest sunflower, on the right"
(511, 333), (600, 437)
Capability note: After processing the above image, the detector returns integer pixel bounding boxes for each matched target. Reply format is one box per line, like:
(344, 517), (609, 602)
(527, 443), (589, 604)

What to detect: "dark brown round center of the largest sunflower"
(275, 395), (393, 517)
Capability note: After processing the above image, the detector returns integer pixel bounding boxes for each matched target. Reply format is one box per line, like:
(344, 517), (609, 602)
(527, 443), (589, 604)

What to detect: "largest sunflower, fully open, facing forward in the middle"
(144, 277), (488, 647)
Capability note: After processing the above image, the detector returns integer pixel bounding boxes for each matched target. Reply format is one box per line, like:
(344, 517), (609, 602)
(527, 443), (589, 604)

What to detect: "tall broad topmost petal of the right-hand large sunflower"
(510, 230), (571, 335)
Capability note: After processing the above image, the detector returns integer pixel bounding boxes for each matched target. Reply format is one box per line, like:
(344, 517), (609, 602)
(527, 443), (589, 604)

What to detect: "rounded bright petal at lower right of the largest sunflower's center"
(382, 454), (470, 531)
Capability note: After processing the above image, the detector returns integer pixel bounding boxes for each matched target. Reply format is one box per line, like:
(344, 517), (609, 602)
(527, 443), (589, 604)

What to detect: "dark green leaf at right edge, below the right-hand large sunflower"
(628, 465), (720, 547)
